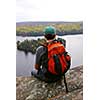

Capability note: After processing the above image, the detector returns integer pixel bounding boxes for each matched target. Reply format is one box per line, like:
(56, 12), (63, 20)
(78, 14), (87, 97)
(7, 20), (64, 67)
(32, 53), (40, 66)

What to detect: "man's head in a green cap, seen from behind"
(44, 26), (56, 40)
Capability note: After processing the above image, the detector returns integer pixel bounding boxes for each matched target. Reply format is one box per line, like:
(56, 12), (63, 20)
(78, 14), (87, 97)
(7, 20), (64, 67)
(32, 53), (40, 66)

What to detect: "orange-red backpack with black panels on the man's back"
(47, 41), (71, 75)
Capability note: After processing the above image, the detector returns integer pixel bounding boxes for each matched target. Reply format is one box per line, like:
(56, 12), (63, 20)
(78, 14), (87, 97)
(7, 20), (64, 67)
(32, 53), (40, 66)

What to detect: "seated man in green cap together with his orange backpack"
(31, 26), (70, 82)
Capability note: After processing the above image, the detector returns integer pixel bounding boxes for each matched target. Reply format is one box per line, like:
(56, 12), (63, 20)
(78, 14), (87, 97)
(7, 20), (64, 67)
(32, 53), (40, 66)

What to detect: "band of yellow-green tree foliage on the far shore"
(16, 23), (81, 33)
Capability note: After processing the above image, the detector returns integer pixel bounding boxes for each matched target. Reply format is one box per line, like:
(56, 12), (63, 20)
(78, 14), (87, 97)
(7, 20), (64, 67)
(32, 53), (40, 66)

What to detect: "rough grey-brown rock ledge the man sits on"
(16, 66), (83, 100)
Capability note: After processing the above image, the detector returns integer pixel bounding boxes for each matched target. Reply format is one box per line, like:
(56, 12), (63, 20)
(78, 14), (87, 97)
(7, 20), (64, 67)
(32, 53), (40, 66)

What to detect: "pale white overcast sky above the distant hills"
(16, 0), (84, 22)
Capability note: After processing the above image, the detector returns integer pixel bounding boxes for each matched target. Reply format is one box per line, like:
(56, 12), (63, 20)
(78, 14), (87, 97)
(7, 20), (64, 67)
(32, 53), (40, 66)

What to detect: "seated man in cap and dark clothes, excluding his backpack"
(31, 26), (70, 82)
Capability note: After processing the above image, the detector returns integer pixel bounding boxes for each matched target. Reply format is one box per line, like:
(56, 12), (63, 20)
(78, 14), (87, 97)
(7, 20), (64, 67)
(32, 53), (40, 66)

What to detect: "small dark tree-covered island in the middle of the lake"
(17, 38), (65, 54)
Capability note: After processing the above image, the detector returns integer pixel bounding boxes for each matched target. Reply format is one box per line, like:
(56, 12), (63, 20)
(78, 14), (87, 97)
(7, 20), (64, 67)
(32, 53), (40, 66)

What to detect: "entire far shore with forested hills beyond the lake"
(16, 22), (83, 36)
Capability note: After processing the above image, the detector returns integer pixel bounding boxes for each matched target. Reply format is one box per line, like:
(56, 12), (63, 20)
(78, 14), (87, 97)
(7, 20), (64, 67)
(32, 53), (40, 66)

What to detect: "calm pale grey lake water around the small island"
(16, 35), (83, 76)
